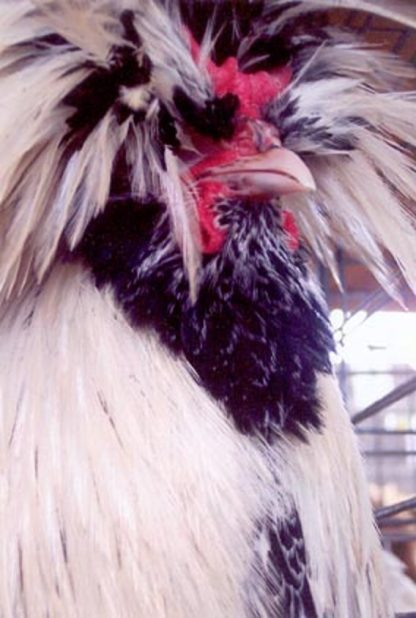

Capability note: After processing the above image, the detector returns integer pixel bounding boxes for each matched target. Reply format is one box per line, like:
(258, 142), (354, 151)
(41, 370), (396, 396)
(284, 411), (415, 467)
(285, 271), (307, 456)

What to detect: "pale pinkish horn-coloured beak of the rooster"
(206, 146), (316, 197)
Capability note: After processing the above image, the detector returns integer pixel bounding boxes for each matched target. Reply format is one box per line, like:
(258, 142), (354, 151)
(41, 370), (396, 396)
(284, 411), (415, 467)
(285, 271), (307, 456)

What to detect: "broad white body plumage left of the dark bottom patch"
(0, 267), (284, 618)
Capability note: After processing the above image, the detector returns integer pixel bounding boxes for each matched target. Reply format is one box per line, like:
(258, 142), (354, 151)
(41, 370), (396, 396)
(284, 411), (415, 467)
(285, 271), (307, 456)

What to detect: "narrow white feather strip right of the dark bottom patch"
(282, 376), (392, 618)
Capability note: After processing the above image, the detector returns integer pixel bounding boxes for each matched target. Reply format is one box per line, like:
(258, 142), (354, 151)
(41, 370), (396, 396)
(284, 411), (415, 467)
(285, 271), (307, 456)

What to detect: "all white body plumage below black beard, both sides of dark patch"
(0, 265), (391, 618)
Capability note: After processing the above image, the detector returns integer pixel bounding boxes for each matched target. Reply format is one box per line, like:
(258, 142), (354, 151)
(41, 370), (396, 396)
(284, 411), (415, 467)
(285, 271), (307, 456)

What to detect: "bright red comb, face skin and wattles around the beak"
(190, 41), (299, 254)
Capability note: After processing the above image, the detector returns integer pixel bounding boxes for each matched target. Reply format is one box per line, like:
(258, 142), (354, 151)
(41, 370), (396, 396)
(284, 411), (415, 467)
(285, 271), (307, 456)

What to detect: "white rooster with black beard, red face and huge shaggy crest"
(0, 0), (416, 618)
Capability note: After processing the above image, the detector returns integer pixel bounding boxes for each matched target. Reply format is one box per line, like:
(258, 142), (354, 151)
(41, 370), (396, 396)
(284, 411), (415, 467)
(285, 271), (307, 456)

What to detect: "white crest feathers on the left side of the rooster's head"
(0, 0), (208, 297)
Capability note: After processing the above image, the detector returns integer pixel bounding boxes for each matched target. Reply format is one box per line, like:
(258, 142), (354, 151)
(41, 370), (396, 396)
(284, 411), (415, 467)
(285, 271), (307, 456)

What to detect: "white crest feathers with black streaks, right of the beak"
(269, 30), (416, 293)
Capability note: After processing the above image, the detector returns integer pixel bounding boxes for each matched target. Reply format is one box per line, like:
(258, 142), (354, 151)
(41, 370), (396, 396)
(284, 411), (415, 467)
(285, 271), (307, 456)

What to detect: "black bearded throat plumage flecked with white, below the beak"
(80, 195), (333, 440)
